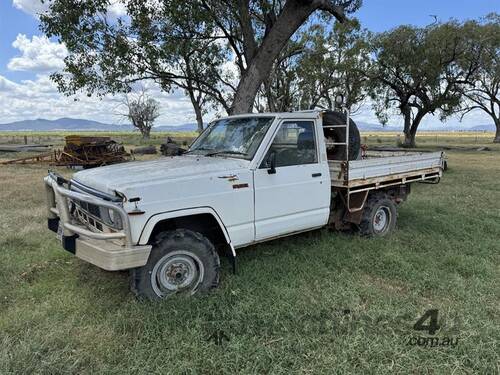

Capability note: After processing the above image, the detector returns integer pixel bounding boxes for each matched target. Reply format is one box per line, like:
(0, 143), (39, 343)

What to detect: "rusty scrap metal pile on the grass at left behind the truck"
(0, 135), (131, 168)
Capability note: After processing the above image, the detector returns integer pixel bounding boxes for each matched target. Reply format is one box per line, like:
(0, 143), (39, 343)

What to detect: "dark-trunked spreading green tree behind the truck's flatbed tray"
(369, 21), (478, 147)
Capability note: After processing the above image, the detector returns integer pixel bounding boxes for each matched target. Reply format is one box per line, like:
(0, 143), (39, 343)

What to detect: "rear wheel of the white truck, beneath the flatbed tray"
(358, 193), (397, 237)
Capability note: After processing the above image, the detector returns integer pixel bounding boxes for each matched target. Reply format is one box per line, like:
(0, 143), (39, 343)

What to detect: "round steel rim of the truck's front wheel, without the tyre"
(151, 250), (205, 298)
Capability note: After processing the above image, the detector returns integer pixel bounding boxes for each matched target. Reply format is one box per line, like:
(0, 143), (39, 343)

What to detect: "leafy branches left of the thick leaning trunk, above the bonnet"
(41, 0), (231, 132)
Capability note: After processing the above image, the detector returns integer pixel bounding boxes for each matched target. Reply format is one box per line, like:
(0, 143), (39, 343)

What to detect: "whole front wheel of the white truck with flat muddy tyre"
(130, 229), (220, 299)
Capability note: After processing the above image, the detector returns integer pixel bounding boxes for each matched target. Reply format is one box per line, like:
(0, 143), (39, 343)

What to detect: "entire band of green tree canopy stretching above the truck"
(41, 0), (500, 146)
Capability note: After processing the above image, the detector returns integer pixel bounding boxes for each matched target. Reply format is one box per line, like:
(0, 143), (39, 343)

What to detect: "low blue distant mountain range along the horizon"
(0, 117), (495, 132)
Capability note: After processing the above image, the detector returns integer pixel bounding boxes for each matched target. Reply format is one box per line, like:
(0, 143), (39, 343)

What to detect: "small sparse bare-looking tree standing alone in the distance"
(124, 89), (160, 139)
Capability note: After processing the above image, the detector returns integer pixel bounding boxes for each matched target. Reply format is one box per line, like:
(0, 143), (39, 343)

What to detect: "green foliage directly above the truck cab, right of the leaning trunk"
(260, 19), (370, 112)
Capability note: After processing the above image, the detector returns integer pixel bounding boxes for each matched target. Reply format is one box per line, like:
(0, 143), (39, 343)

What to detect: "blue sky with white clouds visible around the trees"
(0, 0), (500, 129)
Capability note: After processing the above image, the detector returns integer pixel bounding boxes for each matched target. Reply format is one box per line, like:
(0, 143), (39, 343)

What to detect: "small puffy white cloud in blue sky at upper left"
(7, 34), (68, 72)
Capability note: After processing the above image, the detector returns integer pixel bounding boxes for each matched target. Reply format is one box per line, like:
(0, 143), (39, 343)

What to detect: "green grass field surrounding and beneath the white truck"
(0, 134), (500, 374)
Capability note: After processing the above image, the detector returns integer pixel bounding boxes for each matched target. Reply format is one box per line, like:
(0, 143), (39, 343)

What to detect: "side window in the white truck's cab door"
(260, 121), (318, 168)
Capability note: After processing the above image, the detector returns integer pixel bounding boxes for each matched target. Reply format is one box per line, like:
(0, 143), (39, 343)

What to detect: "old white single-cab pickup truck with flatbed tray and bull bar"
(44, 110), (445, 299)
